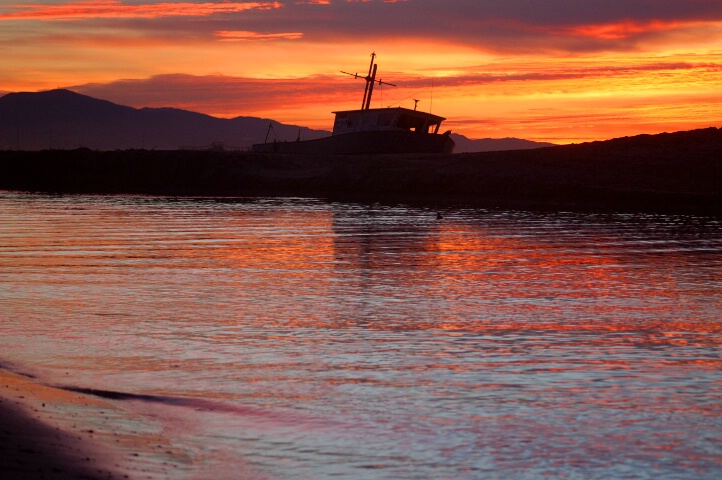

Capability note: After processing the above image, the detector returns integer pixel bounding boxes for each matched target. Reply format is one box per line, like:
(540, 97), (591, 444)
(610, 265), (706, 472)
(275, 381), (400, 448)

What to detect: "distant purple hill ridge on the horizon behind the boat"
(0, 89), (553, 153)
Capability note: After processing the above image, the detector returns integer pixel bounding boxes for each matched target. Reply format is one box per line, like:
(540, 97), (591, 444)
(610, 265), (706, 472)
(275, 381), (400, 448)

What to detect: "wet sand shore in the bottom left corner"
(0, 368), (188, 480)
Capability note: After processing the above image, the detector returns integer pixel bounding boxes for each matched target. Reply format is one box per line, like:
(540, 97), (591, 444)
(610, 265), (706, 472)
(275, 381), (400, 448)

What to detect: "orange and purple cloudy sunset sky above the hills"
(0, 0), (722, 143)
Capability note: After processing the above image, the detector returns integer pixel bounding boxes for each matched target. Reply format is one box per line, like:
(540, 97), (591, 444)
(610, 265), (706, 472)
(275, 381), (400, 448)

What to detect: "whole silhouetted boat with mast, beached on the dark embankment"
(252, 54), (454, 155)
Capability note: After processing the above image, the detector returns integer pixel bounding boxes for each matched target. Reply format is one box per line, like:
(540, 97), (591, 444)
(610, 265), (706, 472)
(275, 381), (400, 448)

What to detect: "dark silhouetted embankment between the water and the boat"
(0, 128), (722, 215)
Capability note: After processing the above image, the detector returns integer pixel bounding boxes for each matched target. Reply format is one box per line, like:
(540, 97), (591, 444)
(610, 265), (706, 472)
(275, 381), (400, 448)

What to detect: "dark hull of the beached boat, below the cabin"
(251, 131), (454, 155)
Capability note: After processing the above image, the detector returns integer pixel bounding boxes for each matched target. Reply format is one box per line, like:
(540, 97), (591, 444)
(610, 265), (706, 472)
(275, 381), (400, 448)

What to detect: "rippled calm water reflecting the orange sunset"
(0, 192), (722, 479)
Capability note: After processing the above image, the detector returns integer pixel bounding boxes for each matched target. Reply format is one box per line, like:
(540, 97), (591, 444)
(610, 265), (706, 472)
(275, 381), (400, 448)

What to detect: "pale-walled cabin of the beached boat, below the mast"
(333, 107), (446, 135)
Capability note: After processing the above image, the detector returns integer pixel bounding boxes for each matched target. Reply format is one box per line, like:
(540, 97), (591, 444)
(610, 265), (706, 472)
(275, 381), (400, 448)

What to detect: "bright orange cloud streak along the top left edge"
(0, 0), (282, 20)
